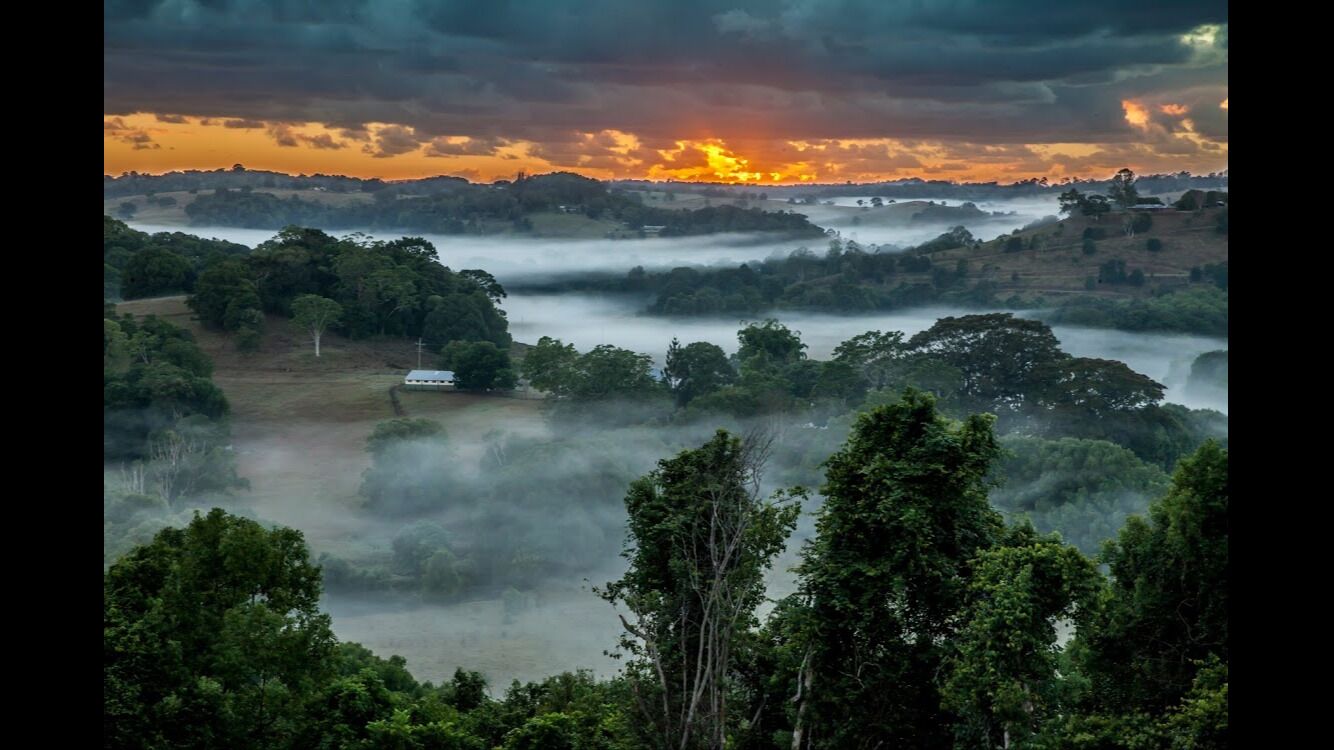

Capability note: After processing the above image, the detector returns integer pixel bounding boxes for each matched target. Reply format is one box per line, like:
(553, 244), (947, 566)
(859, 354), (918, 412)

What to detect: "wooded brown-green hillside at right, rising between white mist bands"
(520, 208), (1227, 336)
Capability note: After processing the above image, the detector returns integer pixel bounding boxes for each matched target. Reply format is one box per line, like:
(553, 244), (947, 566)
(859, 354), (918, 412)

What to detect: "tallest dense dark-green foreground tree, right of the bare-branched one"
(792, 388), (1002, 750)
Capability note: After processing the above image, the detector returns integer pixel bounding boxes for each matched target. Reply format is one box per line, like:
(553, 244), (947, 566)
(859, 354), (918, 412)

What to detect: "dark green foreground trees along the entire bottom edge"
(103, 390), (1230, 750)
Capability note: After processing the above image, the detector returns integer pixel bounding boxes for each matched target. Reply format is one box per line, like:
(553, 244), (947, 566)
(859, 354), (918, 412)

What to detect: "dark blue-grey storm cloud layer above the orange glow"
(104, 0), (1227, 144)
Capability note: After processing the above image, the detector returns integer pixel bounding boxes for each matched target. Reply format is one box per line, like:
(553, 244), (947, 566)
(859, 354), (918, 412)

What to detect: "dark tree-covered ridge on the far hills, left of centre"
(168, 172), (823, 238)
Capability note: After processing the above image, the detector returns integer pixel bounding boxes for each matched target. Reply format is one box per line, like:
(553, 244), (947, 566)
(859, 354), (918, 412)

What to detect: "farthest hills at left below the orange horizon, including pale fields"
(103, 171), (822, 238)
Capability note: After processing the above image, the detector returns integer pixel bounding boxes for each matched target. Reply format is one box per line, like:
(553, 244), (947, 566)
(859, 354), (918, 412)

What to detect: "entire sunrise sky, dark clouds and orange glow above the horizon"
(103, 0), (1227, 184)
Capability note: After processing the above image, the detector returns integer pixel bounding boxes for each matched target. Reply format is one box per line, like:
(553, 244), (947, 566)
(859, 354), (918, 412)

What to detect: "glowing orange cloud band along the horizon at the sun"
(103, 110), (1227, 184)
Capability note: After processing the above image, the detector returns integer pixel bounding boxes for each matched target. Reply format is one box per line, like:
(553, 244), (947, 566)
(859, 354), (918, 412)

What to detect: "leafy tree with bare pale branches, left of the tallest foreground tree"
(603, 430), (799, 750)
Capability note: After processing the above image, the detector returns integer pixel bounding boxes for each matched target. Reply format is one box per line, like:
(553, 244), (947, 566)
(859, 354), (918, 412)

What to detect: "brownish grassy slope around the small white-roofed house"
(110, 296), (544, 539)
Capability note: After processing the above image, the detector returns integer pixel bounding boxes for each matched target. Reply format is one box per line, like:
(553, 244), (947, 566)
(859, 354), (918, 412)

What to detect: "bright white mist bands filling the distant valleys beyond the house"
(132, 220), (1227, 414)
